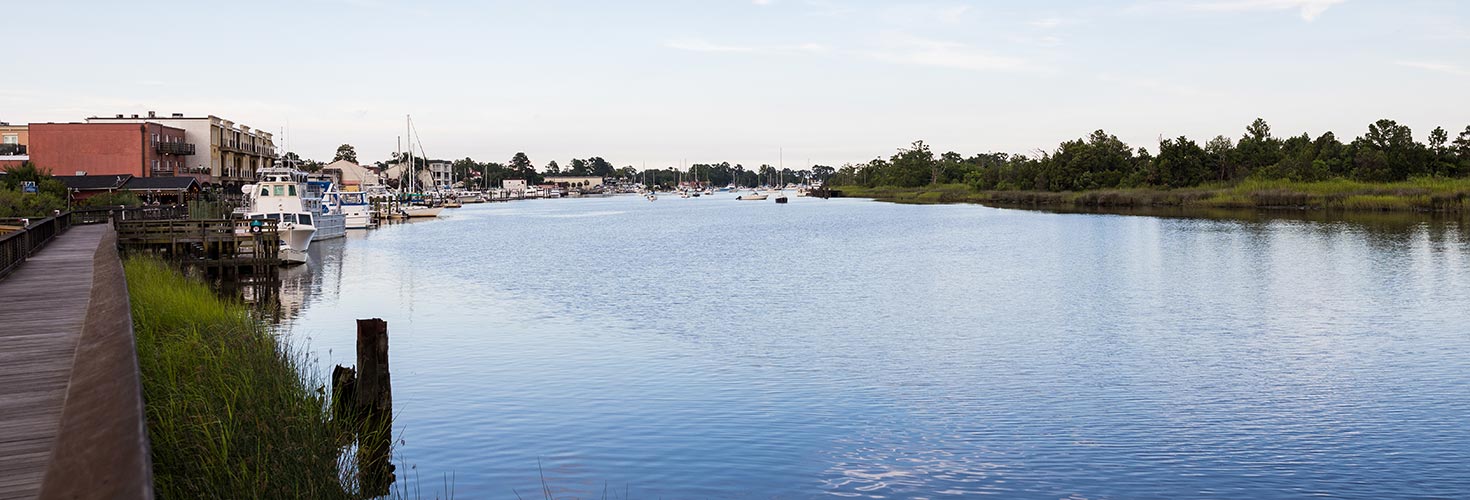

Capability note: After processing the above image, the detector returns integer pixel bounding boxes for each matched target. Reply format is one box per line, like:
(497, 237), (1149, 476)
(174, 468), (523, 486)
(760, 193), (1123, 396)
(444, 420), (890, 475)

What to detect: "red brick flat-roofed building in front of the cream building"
(26, 124), (195, 176)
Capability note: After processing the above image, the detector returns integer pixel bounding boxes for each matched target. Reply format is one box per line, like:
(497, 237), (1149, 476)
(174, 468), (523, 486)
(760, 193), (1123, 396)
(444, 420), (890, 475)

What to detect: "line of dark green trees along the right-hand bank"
(831, 118), (1470, 191)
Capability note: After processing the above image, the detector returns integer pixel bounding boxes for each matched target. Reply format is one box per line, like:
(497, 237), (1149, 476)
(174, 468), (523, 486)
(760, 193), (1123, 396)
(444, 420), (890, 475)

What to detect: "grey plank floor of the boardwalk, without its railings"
(0, 224), (110, 499)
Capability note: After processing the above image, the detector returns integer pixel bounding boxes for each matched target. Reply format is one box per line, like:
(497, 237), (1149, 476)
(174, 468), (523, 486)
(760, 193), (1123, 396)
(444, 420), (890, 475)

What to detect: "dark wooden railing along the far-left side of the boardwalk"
(0, 204), (188, 278)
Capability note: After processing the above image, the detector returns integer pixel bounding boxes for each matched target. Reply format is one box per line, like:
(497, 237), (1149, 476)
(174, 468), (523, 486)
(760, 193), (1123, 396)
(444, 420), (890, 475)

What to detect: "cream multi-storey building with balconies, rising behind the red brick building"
(87, 112), (276, 196)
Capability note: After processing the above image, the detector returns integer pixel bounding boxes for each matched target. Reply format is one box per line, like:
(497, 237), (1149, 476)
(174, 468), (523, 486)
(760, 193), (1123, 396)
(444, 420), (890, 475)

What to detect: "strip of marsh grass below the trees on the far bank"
(833, 178), (1470, 213)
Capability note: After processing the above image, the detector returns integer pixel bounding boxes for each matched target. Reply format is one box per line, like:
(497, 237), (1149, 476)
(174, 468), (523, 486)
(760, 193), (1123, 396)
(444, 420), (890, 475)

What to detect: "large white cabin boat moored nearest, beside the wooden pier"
(241, 165), (319, 263)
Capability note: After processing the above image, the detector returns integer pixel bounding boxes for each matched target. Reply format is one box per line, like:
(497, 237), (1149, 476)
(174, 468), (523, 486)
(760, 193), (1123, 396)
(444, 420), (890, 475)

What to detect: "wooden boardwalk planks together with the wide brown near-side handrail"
(0, 224), (151, 499)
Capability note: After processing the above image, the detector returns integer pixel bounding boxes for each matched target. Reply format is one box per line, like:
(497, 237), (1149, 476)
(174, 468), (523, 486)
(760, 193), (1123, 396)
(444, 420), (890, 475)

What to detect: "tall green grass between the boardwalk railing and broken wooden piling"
(123, 257), (351, 499)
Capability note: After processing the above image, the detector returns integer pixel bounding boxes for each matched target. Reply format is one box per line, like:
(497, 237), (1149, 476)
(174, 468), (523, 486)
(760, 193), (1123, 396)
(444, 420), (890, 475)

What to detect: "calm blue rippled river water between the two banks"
(282, 196), (1470, 499)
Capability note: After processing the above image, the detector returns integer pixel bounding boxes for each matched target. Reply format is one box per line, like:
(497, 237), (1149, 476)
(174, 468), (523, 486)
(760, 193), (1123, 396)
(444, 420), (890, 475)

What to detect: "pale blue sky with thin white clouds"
(0, 0), (1470, 168)
